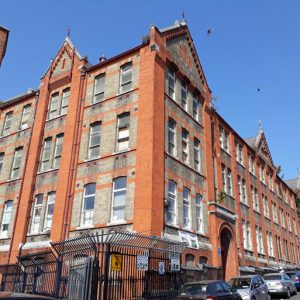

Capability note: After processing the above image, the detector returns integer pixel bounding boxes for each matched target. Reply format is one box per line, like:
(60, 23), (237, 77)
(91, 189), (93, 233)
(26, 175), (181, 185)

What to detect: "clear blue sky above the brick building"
(0, 0), (300, 179)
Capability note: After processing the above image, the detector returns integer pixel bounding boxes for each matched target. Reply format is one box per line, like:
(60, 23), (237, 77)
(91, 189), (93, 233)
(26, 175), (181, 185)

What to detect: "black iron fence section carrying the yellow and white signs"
(99, 232), (185, 300)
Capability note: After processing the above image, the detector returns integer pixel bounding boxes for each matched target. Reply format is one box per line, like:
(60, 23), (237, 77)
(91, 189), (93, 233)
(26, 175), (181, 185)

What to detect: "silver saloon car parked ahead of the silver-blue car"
(264, 273), (297, 298)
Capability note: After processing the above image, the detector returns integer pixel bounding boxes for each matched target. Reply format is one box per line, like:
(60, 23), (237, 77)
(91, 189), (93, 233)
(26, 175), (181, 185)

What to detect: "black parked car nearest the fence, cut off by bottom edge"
(176, 280), (242, 300)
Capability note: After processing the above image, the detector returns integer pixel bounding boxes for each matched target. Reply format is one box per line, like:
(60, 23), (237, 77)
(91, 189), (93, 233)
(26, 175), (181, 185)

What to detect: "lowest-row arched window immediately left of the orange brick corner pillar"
(111, 177), (127, 221)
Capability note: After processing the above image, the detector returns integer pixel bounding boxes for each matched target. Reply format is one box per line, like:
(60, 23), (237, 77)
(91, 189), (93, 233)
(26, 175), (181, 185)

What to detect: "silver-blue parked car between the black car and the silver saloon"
(229, 275), (271, 300)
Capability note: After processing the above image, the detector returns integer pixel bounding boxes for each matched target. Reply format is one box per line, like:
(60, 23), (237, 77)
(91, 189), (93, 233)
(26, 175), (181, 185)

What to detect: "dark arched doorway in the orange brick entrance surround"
(220, 227), (233, 280)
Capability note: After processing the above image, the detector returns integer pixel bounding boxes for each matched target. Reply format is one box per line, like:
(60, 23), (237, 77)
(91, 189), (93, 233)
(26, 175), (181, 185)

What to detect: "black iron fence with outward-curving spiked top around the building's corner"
(0, 232), (192, 300)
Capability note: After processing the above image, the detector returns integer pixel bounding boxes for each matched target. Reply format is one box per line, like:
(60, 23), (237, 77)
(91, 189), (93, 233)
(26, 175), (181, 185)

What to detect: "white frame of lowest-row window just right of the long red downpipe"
(80, 182), (97, 227)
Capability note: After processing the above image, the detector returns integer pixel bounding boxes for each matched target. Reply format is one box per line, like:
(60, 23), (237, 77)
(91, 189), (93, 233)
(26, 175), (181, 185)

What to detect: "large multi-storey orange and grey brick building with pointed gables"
(0, 21), (300, 278)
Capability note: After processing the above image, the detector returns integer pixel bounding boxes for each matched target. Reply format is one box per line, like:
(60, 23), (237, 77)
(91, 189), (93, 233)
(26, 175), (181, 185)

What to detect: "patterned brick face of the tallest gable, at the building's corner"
(166, 32), (205, 88)
